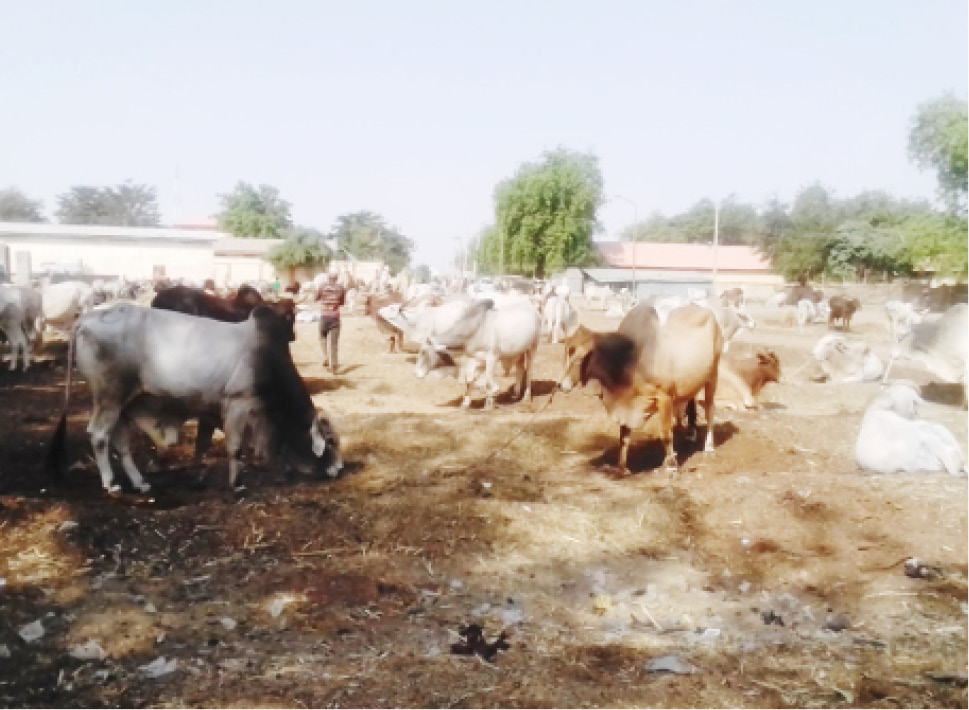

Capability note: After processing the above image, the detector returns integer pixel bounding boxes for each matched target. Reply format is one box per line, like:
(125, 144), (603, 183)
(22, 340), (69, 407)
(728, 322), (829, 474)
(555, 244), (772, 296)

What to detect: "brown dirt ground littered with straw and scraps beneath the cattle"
(0, 298), (969, 707)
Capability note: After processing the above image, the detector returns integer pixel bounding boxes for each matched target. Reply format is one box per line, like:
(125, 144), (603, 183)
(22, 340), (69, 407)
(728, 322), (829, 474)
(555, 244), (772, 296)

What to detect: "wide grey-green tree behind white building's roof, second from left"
(54, 180), (160, 227)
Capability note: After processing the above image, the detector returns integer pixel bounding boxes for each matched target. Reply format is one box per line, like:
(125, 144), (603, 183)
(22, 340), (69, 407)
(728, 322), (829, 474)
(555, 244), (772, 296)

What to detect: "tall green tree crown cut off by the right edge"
(908, 94), (969, 215)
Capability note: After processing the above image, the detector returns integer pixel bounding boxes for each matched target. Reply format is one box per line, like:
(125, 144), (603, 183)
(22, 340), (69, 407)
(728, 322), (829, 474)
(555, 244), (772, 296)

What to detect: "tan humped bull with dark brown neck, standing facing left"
(571, 305), (723, 472)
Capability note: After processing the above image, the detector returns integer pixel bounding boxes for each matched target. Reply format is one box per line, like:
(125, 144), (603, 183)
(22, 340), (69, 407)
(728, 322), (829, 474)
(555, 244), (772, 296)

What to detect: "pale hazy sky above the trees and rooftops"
(0, 0), (969, 266)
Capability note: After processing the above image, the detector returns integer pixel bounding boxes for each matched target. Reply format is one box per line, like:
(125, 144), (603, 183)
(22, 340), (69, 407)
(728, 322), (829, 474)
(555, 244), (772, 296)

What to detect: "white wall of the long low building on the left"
(4, 235), (215, 281)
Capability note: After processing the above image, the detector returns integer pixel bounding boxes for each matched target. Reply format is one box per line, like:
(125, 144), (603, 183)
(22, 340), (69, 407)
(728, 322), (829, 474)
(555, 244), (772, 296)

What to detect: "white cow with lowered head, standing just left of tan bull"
(415, 299), (542, 409)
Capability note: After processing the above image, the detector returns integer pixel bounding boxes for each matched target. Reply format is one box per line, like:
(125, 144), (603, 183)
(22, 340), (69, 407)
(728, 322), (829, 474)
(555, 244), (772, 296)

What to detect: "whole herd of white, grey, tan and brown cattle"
(0, 281), (967, 498)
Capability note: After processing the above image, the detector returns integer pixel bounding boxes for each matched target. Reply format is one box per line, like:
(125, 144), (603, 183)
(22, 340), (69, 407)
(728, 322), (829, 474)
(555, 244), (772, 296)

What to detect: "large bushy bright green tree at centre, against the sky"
(495, 148), (603, 277)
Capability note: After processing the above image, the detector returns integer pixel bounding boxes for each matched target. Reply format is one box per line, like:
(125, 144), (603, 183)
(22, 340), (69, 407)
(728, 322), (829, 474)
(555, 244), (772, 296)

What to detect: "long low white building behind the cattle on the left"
(0, 222), (282, 286)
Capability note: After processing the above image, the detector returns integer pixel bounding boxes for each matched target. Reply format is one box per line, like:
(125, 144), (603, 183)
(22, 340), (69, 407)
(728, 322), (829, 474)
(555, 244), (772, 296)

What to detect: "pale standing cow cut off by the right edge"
(885, 303), (969, 404)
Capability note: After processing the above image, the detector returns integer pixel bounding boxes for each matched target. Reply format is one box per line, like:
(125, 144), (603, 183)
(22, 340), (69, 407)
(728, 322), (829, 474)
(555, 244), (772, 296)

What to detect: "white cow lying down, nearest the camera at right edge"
(855, 384), (966, 476)
